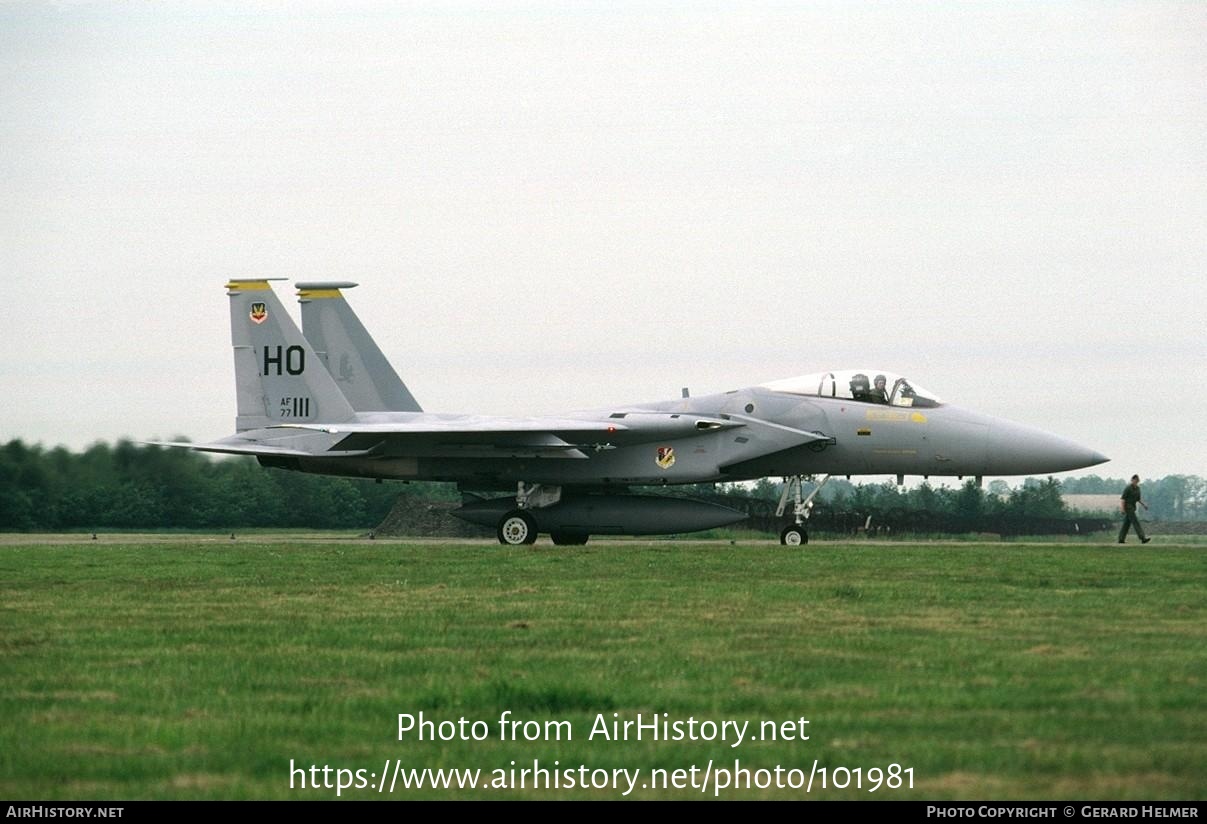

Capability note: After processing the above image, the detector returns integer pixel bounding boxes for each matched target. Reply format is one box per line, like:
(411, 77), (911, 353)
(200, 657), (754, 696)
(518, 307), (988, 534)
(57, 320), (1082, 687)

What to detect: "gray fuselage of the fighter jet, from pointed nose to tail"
(263, 387), (1106, 489)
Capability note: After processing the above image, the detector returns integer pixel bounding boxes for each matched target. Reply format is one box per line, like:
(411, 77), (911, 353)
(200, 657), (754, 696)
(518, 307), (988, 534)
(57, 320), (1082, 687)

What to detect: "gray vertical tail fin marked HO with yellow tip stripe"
(226, 279), (356, 432)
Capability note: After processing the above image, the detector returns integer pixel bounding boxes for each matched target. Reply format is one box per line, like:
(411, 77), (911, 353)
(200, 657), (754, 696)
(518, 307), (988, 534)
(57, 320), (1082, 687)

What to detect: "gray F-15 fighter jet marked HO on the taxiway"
(162, 279), (1108, 545)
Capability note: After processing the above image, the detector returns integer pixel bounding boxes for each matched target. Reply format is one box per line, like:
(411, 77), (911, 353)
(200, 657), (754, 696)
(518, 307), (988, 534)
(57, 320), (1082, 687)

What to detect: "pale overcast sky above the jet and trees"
(0, 0), (1207, 477)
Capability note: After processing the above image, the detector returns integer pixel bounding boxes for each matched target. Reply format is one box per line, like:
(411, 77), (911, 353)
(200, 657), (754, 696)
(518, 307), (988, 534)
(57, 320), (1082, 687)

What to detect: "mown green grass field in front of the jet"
(0, 536), (1207, 800)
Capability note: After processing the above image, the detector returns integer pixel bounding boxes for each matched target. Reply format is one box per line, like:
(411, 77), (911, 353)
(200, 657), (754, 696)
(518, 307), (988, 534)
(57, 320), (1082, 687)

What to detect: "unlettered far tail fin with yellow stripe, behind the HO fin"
(297, 281), (422, 411)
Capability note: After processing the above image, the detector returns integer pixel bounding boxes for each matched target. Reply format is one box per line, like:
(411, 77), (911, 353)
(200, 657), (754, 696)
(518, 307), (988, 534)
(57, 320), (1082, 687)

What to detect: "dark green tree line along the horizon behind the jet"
(0, 440), (1207, 532)
